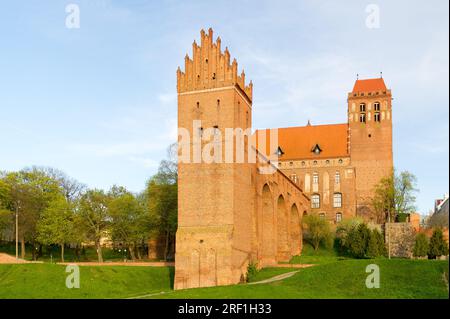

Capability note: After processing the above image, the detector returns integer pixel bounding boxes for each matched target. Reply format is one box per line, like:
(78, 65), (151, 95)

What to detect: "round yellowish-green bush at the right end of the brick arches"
(303, 215), (333, 250)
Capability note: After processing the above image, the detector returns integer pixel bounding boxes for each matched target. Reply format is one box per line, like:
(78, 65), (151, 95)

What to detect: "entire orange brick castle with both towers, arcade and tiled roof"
(174, 29), (393, 289)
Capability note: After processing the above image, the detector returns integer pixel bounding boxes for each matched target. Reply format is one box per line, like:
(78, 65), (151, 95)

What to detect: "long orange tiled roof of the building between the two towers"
(258, 124), (348, 161)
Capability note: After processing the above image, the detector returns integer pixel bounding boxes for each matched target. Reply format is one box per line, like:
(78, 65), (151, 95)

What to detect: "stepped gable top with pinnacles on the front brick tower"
(177, 28), (253, 101)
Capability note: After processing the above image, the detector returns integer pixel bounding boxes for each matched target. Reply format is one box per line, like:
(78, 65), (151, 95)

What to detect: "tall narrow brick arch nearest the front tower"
(260, 184), (276, 266)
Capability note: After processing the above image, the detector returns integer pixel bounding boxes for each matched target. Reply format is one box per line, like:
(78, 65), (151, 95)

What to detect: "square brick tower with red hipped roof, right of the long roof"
(348, 78), (393, 219)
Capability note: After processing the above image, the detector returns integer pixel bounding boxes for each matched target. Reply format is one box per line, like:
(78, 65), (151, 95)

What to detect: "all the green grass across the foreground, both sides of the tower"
(0, 245), (448, 299)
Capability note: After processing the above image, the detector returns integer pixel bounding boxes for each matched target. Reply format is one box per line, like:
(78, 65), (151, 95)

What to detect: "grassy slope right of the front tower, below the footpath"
(154, 259), (448, 299)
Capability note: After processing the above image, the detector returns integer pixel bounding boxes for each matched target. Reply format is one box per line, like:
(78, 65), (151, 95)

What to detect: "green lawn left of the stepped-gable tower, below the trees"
(0, 264), (173, 299)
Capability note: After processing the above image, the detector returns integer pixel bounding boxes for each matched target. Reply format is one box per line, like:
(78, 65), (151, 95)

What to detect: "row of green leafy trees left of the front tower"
(0, 148), (178, 261)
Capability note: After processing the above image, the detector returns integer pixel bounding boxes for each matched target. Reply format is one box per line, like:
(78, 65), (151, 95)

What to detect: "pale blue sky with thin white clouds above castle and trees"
(0, 0), (449, 213)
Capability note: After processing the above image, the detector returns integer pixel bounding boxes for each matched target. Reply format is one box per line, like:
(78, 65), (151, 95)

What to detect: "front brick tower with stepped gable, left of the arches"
(174, 29), (254, 289)
